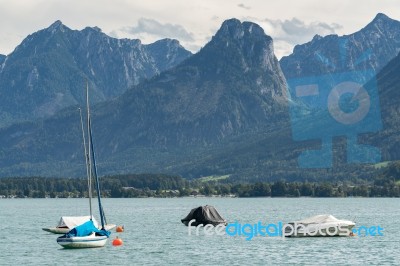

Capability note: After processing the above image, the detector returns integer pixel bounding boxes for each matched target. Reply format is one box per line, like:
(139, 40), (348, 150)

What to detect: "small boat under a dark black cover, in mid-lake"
(181, 205), (227, 226)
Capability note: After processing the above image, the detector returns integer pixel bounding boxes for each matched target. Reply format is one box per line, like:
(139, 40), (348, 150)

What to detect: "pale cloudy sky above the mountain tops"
(0, 0), (400, 58)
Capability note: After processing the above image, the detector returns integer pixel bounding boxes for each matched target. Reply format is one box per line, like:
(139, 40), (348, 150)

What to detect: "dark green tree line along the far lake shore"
(0, 166), (400, 198)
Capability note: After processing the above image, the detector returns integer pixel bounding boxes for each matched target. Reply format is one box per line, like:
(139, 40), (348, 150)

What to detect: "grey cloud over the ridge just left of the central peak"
(121, 18), (194, 42)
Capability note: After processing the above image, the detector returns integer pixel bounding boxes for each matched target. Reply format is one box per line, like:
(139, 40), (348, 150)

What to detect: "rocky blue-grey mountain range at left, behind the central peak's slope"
(0, 21), (191, 126)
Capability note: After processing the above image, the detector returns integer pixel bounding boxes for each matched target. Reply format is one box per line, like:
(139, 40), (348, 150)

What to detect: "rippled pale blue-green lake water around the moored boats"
(0, 198), (400, 265)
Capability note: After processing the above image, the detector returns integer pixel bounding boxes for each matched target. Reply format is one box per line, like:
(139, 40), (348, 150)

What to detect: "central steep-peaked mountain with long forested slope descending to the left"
(0, 17), (287, 178)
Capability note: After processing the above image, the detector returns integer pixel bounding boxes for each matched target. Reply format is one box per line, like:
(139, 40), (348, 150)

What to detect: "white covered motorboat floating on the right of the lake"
(282, 214), (356, 237)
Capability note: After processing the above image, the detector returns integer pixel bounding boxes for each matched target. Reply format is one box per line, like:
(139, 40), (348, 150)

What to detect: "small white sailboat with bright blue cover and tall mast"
(57, 84), (110, 248)
